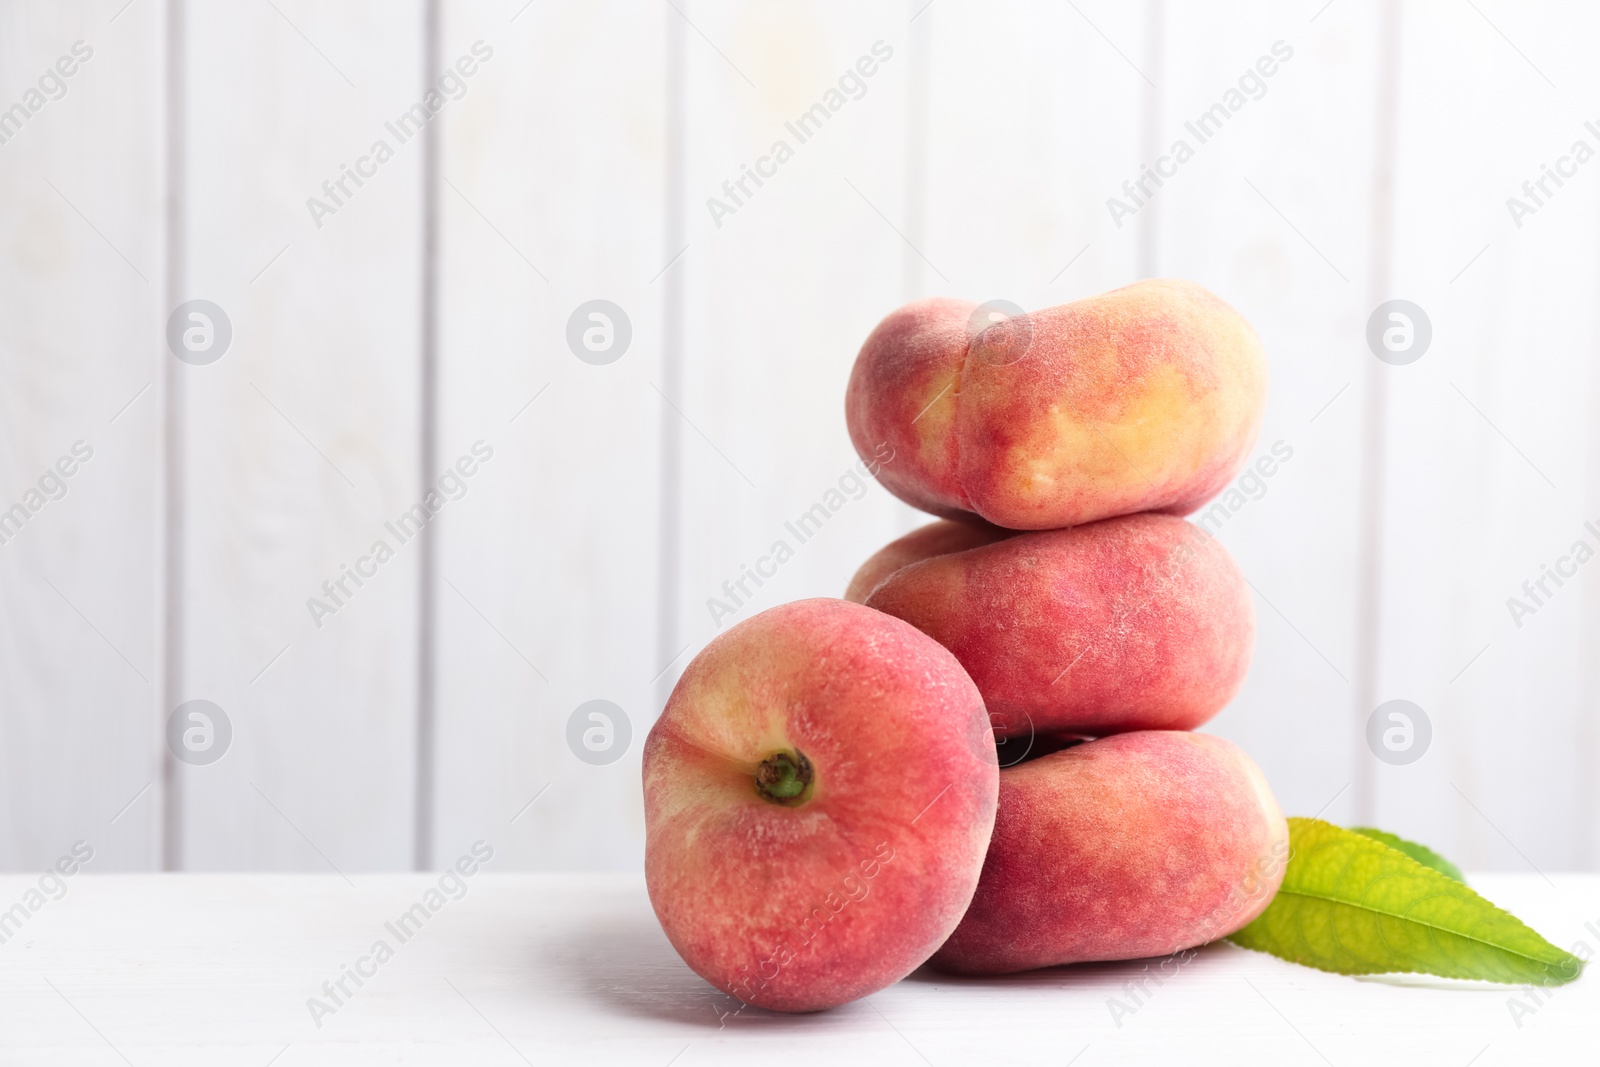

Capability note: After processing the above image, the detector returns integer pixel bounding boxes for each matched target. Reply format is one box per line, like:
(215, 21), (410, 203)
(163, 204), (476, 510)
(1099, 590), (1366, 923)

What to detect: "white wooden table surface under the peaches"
(0, 872), (1600, 1067)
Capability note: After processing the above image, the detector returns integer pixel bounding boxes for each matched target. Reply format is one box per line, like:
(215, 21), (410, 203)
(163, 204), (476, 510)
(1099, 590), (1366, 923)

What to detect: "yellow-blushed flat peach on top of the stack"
(845, 280), (1267, 530)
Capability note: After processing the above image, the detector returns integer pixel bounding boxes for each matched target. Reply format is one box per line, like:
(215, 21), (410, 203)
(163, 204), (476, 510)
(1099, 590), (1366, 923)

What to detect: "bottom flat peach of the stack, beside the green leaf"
(933, 731), (1288, 974)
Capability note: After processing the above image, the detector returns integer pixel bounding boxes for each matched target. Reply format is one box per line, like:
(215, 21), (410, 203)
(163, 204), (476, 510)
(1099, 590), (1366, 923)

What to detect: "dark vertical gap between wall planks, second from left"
(411, 0), (443, 870)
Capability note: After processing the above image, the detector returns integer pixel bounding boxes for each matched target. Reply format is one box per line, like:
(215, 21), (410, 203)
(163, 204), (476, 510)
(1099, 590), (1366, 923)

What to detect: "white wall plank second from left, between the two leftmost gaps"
(181, 0), (424, 870)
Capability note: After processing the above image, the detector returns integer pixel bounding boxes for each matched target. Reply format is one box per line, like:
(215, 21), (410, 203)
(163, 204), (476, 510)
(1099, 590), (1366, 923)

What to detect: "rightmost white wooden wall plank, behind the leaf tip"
(1378, 3), (1600, 870)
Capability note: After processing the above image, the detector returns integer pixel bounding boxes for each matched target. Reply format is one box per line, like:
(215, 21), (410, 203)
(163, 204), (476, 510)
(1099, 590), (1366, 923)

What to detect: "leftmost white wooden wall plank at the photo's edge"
(0, 3), (170, 869)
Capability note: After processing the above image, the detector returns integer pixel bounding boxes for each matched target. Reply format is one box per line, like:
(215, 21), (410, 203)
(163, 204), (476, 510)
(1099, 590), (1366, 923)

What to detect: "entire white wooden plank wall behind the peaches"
(0, 0), (1600, 870)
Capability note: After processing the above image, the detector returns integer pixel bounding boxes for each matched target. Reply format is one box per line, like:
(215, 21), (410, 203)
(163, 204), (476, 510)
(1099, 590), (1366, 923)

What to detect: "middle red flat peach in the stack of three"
(867, 515), (1256, 737)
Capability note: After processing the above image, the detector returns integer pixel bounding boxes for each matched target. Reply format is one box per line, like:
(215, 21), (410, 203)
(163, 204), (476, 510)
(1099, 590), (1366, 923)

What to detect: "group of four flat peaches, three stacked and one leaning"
(643, 280), (1288, 1011)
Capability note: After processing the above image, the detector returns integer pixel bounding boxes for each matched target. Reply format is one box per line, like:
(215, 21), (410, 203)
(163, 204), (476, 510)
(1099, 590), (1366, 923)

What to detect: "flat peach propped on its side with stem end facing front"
(643, 598), (998, 1011)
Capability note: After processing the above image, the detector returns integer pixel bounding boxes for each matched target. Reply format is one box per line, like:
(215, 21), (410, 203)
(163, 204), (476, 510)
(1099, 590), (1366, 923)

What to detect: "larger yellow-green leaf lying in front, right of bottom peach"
(1229, 819), (1582, 985)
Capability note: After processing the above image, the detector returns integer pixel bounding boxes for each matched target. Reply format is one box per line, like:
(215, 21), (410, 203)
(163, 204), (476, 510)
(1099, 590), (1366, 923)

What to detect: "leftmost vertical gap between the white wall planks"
(155, 0), (189, 870)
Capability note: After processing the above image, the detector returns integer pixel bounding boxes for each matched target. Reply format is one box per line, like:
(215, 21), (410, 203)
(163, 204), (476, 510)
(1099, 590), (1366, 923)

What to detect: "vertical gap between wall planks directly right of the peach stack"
(1350, 0), (1400, 824)
